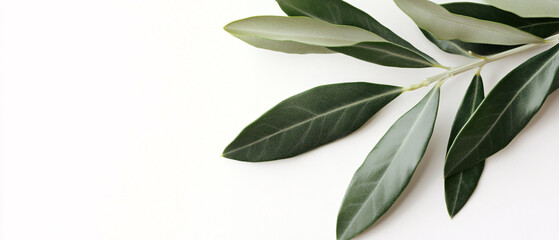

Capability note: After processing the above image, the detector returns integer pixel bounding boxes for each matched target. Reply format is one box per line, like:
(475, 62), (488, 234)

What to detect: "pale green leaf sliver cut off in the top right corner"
(484, 0), (559, 17)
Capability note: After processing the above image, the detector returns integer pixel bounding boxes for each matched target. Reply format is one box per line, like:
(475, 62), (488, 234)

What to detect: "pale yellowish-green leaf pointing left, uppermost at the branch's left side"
(225, 16), (386, 53)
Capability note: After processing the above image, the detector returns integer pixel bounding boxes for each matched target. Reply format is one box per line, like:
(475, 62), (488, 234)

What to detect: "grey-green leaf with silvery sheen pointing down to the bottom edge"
(336, 86), (440, 239)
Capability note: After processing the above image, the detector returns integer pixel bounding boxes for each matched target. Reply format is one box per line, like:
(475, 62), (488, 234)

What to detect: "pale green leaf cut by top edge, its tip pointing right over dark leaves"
(394, 0), (543, 45)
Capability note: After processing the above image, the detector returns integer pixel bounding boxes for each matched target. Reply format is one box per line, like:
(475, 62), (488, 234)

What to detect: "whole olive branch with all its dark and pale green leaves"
(223, 0), (559, 239)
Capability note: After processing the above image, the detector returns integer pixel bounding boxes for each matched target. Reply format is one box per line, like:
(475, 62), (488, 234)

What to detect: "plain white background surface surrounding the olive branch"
(1, 0), (559, 240)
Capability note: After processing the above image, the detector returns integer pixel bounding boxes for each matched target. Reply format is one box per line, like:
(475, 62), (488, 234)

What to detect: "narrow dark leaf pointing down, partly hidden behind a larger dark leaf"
(444, 74), (485, 217)
